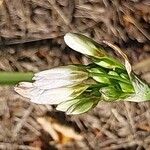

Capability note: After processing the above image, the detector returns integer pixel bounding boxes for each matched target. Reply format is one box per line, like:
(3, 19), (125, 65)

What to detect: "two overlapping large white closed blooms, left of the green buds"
(15, 65), (88, 104)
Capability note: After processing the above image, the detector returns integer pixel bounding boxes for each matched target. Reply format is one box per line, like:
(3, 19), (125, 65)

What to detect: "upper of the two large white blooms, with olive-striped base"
(33, 65), (88, 89)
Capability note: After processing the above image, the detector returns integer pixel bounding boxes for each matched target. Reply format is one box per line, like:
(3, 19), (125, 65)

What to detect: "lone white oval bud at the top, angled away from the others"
(64, 33), (105, 58)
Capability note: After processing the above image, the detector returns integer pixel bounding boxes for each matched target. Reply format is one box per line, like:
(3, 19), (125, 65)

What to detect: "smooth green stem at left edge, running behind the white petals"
(0, 71), (33, 85)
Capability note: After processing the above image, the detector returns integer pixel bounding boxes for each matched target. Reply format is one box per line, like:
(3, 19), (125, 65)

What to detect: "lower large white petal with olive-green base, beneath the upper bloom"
(29, 85), (89, 105)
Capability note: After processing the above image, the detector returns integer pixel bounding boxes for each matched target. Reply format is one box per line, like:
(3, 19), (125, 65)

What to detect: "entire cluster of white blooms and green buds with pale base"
(15, 33), (150, 114)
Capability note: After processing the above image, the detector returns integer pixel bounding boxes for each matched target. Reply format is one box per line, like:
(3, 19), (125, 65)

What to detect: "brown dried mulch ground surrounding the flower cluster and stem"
(0, 0), (150, 150)
